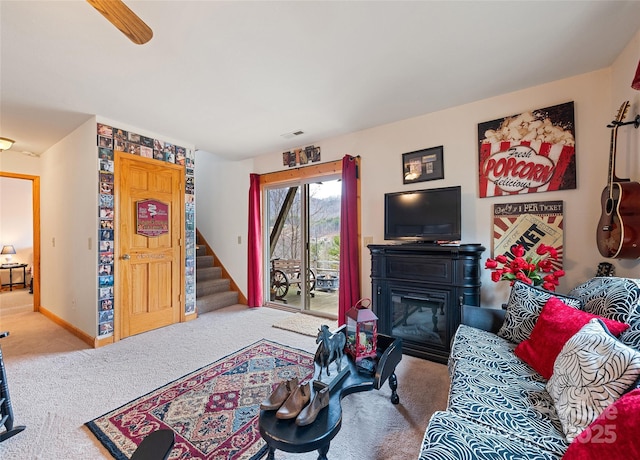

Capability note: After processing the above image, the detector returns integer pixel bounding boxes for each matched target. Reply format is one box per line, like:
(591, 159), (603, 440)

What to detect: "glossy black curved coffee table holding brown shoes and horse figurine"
(258, 334), (402, 460)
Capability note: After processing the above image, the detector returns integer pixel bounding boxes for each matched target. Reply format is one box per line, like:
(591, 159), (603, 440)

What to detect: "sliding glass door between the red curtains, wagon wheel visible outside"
(263, 178), (341, 316)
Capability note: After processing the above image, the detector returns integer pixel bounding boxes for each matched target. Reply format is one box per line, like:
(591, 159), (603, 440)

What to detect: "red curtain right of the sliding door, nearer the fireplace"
(338, 155), (360, 326)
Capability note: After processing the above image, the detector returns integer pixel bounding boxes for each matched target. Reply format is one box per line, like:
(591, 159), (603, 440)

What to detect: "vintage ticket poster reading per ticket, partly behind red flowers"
(492, 201), (564, 270)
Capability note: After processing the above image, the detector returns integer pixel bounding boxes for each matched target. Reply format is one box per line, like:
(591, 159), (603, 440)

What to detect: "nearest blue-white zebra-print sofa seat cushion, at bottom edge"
(420, 412), (558, 460)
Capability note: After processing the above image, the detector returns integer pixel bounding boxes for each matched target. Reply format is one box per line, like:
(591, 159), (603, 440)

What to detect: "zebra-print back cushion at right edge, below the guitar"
(569, 276), (640, 351)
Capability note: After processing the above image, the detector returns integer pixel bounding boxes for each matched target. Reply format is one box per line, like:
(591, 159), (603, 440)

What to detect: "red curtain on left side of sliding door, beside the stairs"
(247, 174), (263, 307)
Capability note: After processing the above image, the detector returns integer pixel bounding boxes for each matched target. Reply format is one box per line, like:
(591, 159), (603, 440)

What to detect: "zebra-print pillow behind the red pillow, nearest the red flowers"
(498, 281), (582, 343)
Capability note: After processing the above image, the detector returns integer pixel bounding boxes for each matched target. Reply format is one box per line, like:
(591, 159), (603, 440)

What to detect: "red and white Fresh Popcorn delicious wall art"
(478, 102), (576, 198)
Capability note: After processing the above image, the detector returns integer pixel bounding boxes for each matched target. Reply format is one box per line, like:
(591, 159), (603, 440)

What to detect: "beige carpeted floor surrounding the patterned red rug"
(0, 305), (449, 460)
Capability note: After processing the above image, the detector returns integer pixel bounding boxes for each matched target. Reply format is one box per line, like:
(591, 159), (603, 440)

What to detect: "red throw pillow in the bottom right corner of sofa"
(562, 388), (640, 460)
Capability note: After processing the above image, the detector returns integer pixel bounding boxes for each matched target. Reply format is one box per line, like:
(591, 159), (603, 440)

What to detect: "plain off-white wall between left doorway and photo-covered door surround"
(40, 117), (98, 337)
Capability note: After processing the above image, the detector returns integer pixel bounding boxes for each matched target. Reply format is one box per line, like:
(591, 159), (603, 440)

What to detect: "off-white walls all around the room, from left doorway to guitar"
(0, 32), (640, 328)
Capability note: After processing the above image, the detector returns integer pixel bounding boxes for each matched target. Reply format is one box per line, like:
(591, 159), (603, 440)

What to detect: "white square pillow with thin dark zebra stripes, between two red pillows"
(547, 319), (640, 442)
